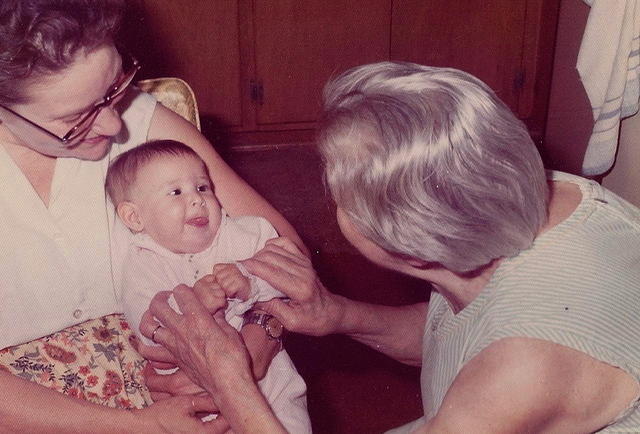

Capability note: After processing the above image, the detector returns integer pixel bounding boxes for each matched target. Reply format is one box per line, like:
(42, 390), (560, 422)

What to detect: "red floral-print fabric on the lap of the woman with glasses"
(0, 314), (152, 409)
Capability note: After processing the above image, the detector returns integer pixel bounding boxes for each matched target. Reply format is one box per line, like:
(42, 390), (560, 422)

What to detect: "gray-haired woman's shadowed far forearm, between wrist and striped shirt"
(335, 296), (427, 366)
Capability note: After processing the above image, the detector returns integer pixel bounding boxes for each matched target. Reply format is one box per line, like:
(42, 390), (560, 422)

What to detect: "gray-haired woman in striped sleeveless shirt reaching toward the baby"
(143, 63), (640, 433)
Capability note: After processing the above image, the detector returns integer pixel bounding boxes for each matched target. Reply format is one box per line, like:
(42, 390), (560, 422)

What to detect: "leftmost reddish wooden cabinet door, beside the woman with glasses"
(134, 0), (242, 127)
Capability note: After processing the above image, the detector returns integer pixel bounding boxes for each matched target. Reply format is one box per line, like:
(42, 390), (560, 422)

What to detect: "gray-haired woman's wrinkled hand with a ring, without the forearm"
(140, 285), (254, 404)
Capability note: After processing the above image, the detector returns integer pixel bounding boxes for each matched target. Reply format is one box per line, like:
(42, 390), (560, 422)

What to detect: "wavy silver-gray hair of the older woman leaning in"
(319, 62), (547, 273)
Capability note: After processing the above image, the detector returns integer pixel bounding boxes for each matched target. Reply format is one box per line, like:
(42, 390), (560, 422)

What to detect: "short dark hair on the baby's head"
(105, 140), (206, 206)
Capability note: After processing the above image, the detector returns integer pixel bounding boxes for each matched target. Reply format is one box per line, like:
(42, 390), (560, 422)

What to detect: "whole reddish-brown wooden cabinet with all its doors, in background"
(121, 0), (559, 143)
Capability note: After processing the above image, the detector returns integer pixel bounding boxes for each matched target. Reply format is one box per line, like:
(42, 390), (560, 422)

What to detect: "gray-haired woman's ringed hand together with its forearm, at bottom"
(140, 285), (285, 432)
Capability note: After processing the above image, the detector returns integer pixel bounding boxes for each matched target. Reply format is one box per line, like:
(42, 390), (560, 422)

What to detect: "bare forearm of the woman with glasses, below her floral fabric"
(0, 371), (143, 433)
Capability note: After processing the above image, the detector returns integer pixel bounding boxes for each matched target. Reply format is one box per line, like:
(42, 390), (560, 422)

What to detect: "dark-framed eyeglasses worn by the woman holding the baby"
(0, 55), (141, 147)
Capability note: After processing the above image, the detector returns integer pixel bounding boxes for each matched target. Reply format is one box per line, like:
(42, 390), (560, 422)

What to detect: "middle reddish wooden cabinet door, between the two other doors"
(254, 0), (391, 126)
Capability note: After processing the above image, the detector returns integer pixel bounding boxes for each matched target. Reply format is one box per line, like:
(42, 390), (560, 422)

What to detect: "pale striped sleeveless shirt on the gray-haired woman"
(390, 172), (640, 433)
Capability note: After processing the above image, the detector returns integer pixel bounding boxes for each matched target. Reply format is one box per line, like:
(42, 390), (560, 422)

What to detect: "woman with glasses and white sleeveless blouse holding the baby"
(0, 0), (299, 432)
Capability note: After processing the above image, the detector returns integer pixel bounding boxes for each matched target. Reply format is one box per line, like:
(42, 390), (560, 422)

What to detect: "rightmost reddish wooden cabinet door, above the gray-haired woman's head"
(391, 0), (534, 117)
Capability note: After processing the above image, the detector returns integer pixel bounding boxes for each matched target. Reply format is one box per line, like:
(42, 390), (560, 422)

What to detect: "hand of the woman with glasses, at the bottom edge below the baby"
(133, 396), (229, 434)
